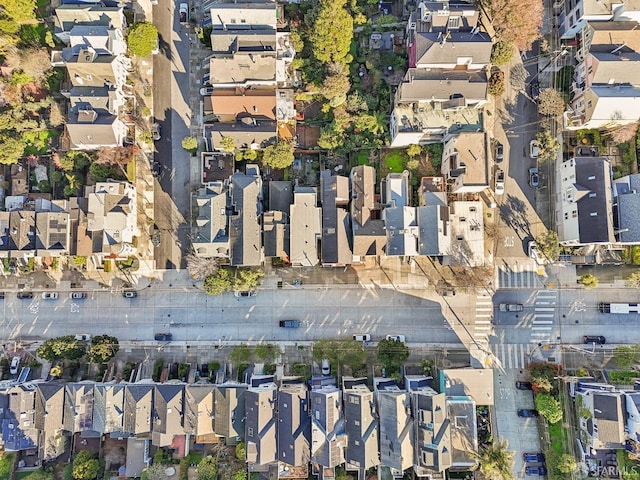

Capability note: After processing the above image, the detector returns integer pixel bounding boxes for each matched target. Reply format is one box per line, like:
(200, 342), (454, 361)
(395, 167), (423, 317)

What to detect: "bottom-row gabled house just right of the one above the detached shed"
(151, 383), (185, 447)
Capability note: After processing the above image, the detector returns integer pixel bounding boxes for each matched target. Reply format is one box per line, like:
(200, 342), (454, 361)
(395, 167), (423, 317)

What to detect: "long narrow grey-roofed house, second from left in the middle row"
(229, 164), (264, 266)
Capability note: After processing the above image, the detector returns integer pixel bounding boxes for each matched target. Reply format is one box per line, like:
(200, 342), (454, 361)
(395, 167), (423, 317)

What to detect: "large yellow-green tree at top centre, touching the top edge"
(309, 0), (353, 63)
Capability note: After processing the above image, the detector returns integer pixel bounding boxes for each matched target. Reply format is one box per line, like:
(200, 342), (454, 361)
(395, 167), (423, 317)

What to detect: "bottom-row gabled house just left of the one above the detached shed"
(93, 383), (128, 437)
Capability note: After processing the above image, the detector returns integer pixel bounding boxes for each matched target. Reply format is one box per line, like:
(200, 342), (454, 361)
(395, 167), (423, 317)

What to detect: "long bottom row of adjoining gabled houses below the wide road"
(0, 369), (493, 479)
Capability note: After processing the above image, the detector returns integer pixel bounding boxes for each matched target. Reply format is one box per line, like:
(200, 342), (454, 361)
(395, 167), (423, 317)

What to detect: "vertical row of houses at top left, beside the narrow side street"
(51, 3), (134, 150)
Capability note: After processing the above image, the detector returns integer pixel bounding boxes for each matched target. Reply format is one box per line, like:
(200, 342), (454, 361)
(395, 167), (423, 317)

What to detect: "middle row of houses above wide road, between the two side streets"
(193, 163), (486, 267)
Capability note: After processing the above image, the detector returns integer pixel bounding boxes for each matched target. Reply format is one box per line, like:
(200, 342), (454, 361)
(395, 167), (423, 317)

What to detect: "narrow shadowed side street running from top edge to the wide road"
(153, 3), (191, 269)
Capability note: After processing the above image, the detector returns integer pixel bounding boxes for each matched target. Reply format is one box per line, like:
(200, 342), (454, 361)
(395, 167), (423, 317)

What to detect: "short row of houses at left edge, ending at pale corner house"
(0, 177), (139, 267)
